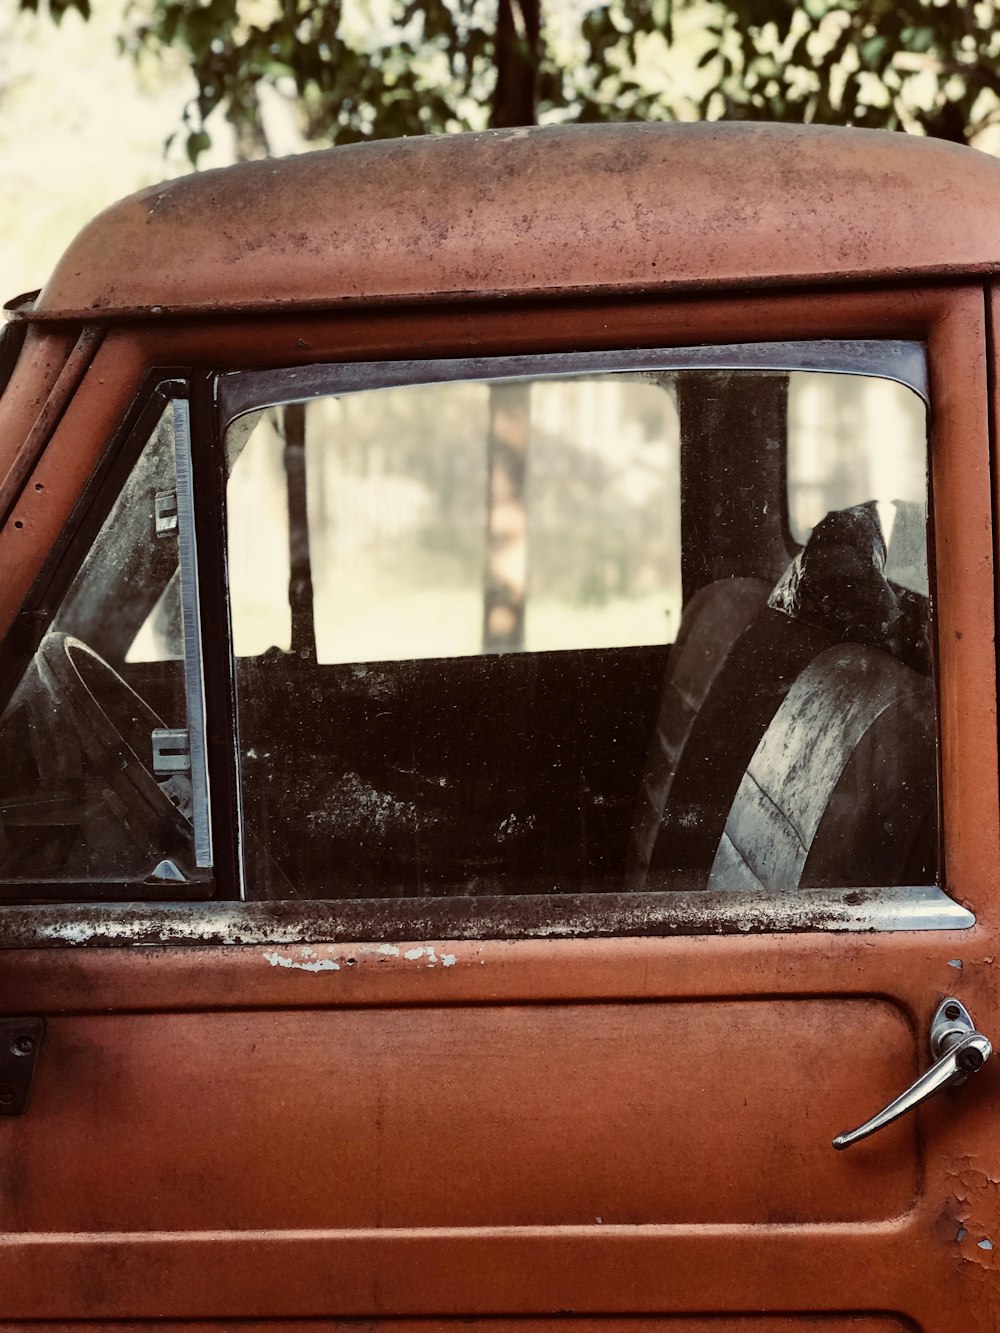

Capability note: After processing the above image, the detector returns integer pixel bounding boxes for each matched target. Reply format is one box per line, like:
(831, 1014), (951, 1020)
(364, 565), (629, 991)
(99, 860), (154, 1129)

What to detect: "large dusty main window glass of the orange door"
(227, 371), (937, 898)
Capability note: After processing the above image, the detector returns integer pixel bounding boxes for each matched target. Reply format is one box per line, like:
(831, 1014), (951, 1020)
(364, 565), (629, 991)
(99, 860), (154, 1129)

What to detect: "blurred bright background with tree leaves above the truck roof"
(0, 0), (1000, 299)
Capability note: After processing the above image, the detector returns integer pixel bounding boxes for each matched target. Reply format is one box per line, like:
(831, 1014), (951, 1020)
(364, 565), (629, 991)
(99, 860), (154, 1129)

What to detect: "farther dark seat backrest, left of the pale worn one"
(625, 579), (771, 889)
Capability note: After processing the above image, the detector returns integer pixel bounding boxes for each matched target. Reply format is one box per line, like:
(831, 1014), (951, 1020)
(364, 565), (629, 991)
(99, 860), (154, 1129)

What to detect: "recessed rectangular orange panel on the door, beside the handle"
(0, 998), (917, 1236)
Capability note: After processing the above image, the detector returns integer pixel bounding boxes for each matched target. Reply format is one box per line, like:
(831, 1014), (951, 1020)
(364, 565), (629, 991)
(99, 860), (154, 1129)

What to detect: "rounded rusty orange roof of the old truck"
(21, 124), (1000, 319)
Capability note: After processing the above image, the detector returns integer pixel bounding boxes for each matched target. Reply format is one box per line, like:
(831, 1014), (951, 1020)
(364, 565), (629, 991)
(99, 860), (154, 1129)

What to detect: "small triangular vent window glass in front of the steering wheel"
(0, 408), (209, 896)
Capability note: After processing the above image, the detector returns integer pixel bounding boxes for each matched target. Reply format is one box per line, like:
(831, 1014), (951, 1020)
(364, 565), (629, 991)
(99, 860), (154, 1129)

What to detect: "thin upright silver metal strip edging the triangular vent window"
(173, 399), (212, 868)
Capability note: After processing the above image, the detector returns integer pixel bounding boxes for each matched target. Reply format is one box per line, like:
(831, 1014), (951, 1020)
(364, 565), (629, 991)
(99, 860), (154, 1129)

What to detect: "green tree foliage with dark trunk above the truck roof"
(20, 0), (1000, 163)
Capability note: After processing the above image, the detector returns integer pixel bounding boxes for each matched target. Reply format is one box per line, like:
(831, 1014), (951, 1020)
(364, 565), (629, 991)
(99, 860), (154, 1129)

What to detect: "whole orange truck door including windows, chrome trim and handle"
(0, 288), (1000, 1333)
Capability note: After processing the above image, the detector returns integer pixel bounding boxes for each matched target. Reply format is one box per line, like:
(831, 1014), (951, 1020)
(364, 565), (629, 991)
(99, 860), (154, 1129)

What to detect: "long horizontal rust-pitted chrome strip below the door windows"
(0, 885), (976, 949)
